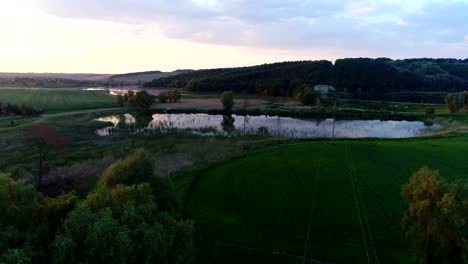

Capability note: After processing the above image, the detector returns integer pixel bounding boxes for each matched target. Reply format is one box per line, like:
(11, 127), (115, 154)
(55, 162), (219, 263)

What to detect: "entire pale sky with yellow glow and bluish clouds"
(0, 0), (468, 73)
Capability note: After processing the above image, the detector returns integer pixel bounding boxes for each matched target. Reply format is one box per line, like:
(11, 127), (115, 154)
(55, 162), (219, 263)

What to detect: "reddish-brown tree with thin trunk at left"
(24, 124), (65, 190)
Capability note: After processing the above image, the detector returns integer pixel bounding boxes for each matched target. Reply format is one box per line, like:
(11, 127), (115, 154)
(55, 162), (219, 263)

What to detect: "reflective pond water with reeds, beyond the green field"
(96, 114), (441, 138)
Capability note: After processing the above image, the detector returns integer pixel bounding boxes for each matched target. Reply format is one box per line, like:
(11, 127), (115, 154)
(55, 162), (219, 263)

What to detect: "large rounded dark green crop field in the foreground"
(186, 136), (468, 263)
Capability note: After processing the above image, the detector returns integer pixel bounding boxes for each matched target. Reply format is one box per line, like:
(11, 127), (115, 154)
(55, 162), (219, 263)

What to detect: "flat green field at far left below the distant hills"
(0, 88), (114, 110)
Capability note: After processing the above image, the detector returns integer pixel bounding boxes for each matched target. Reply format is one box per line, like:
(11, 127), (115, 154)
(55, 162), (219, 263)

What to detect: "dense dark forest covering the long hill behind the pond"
(144, 58), (468, 102)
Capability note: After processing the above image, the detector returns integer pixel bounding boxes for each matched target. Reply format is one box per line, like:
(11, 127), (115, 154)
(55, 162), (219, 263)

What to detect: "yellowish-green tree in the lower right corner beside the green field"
(402, 167), (468, 264)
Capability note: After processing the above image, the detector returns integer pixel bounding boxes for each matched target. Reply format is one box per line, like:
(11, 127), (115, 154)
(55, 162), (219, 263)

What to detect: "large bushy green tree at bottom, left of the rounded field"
(53, 179), (194, 263)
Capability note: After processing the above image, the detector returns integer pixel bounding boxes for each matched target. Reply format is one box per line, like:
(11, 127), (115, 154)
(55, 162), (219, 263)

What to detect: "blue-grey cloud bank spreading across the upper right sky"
(34, 0), (468, 57)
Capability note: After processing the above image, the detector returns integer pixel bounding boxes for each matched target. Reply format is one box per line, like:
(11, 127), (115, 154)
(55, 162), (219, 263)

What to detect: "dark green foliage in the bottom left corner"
(0, 174), (77, 263)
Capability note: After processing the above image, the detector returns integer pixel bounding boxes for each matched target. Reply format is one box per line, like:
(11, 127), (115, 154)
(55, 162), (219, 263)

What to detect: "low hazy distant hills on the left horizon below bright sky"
(0, 70), (187, 88)
